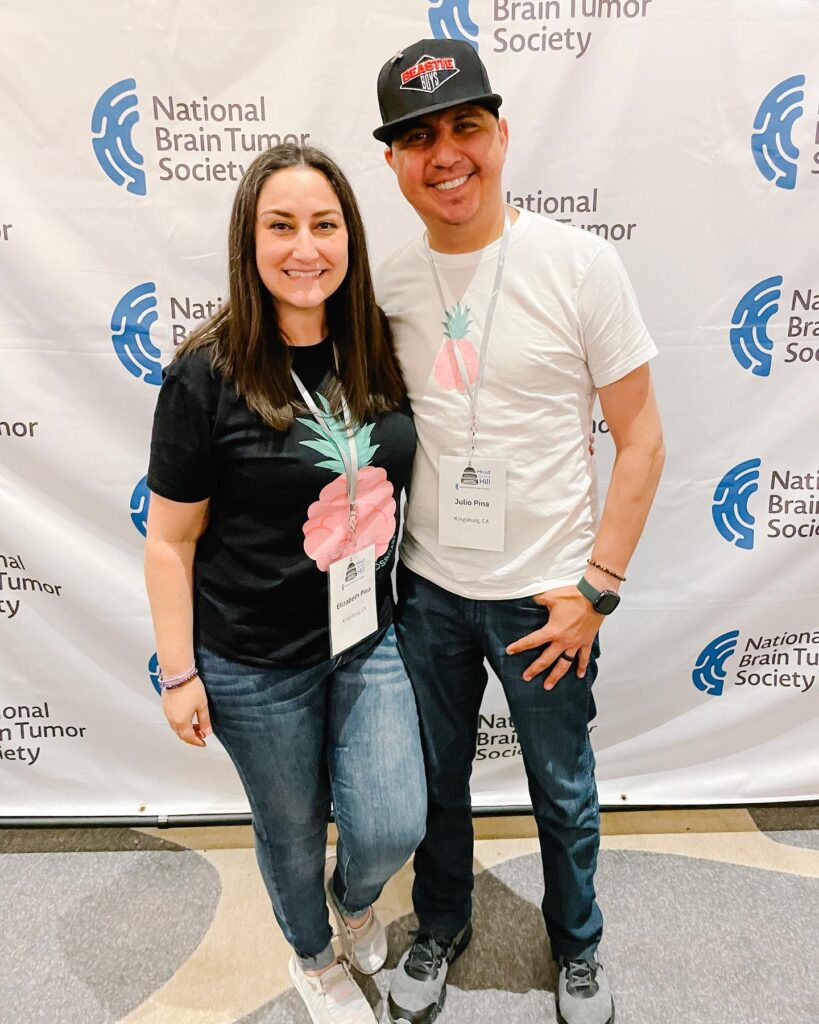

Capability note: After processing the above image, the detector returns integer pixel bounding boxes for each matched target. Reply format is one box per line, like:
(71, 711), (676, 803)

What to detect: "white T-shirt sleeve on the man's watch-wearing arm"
(577, 245), (657, 388)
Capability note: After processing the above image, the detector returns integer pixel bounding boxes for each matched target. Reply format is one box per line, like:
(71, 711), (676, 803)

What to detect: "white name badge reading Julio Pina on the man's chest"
(438, 455), (508, 551)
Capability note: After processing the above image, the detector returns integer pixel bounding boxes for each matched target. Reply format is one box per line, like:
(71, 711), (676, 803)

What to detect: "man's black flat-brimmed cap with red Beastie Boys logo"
(373, 39), (503, 145)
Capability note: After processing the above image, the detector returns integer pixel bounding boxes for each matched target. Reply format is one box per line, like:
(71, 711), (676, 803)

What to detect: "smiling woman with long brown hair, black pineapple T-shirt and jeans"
(145, 145), (426, 1024)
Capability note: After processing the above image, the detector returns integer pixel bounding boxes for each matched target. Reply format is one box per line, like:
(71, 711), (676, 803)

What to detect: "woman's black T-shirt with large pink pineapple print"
(147, 339), (416, 667)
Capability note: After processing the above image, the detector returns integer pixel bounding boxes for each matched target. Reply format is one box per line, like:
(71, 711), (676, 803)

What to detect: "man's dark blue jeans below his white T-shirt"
(396, 564), (603, 958)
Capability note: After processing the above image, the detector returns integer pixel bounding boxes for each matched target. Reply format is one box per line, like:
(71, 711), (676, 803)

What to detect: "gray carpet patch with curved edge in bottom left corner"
(0, 848), (220, 1024)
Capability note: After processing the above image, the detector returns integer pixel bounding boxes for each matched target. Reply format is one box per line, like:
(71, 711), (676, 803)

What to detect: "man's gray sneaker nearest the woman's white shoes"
(387, 923), (472, 1024)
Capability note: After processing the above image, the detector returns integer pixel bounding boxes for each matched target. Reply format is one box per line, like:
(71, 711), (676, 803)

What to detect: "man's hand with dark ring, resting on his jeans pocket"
(506, 587), (605, 690)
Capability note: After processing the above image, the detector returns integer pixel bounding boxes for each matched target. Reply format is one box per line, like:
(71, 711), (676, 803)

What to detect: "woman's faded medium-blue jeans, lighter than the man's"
(197, 627), (426, 970)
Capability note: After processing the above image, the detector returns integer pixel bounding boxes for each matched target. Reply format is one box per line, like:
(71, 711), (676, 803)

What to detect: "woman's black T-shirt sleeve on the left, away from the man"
(147, 354), (216, 502)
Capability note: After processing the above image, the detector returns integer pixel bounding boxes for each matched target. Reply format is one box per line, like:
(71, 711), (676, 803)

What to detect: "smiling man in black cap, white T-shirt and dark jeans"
(374, 40), (662, 1024)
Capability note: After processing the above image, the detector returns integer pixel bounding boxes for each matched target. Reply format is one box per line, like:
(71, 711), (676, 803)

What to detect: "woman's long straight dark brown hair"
(174, 145), (406, 430)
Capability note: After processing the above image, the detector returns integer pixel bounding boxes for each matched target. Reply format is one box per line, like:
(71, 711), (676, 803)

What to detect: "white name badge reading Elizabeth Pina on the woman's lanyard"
(330, 544), (378, 657)
